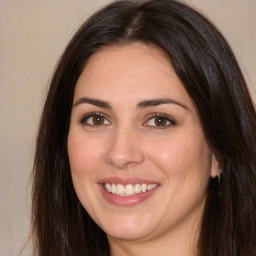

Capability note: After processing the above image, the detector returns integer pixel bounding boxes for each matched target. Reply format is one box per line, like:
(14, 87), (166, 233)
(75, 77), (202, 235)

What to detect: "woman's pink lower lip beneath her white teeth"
(99, 184), (158, 206)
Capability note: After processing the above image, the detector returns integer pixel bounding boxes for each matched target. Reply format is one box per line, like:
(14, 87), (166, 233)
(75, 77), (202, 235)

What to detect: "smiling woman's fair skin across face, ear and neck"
(68, 43), (218, 256)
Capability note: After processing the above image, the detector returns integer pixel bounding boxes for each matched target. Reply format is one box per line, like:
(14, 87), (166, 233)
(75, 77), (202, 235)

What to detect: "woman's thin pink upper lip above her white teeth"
(98, 177), (159, 185)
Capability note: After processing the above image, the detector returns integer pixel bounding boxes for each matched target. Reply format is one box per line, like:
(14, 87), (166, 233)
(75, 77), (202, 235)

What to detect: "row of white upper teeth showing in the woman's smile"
(104, 183), (157, 196)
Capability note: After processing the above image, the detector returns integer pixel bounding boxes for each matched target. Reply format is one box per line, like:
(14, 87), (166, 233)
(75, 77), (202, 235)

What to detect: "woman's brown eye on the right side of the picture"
(143, 114), (176, 129)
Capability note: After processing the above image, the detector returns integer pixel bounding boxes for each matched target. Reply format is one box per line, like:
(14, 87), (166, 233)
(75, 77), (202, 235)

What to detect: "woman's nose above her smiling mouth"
(105, 127), (144, 169)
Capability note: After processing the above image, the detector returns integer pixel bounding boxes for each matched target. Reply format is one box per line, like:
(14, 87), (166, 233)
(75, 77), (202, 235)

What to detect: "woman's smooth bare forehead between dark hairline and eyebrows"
(75, 43), (192, 109)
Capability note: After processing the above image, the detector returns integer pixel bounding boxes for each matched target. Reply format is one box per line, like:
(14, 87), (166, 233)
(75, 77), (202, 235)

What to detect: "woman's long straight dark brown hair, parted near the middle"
(32, 0), (256, 256)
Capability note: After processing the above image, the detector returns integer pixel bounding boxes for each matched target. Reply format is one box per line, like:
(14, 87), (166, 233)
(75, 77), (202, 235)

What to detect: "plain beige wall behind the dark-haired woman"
(0, 0), (256, 256)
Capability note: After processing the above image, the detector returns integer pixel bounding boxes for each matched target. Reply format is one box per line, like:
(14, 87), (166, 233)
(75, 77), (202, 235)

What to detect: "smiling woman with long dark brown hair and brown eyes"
(32, 0), (256, 256)
